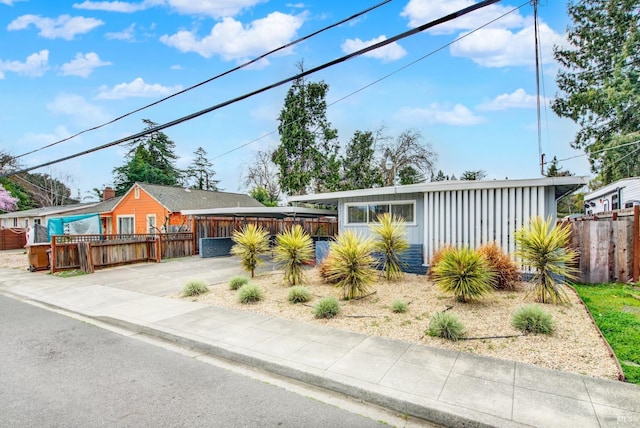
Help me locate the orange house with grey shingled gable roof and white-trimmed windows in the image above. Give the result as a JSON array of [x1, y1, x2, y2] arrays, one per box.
[[68, 183, 264, 234]]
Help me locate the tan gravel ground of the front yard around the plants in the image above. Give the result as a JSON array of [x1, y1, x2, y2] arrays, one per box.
[[179, 269, 618, 379]]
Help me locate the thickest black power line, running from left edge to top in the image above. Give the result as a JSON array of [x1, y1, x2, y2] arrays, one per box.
[[0, 0, 500, 178]]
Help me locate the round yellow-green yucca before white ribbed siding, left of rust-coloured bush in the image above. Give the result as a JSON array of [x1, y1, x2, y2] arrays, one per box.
[[432, 247, 496, 302]]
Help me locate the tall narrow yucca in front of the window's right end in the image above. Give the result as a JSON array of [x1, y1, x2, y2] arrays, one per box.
[[369, 213, 409, 281]]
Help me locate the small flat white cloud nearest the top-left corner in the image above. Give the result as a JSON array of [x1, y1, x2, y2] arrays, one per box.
[[7, 15, 104, 40]]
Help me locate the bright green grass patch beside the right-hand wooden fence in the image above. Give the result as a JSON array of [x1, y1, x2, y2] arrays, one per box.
[[574, 284, 640, 385]]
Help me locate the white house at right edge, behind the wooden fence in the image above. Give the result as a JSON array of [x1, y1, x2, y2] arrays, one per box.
[[584, 177, 640, 215]]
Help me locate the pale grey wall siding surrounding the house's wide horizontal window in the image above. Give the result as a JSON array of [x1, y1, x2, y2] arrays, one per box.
[[338, 193, 424, 245]]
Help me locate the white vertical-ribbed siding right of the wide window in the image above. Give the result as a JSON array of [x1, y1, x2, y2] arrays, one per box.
[[422, 186, 556, 263]]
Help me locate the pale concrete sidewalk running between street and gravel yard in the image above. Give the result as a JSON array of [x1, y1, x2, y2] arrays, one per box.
[[0, 265, 640, 427]]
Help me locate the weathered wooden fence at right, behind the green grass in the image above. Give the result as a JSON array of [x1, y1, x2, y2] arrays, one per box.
[[561, 206, 640, 284]]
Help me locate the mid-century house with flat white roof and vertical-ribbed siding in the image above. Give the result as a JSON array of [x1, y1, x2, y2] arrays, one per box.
[[288, 176, 588, 271]]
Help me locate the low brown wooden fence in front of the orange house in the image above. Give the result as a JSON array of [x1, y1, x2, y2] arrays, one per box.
[[51, 232, 194, 273]]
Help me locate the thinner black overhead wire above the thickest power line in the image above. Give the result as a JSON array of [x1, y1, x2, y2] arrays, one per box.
[[14, 0, 391, 159]]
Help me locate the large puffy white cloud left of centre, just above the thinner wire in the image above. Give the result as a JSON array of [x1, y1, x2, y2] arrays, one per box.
[[160, 12, 303, 61]]
